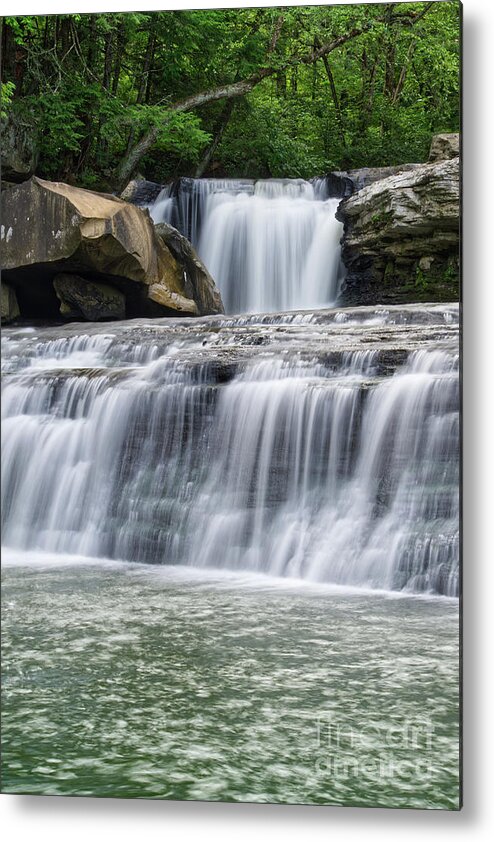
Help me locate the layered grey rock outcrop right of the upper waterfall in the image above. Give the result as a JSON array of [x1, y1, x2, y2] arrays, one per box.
[[337, 158, 459, 304]]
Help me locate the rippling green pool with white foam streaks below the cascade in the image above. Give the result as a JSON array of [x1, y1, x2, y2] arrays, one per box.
[[2, 563, 459, 809]]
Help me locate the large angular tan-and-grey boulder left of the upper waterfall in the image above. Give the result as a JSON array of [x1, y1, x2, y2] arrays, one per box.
[[1, 177, 222, 317]]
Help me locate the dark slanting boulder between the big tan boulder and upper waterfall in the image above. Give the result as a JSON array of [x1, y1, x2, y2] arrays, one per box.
[[155, 222, 224, 313]]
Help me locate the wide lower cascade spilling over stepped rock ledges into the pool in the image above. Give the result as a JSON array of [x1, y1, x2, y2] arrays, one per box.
[[2, 306, 459, 596]]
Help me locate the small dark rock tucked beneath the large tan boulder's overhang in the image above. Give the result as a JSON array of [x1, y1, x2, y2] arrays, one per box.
[[53, 274, 125, 322]]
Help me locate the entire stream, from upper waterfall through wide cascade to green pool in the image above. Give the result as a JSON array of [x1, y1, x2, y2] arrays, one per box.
[[1, 174, 459, 809]]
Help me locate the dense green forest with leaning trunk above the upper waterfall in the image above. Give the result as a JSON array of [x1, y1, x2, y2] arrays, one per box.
[[1, 0, 460, 187]]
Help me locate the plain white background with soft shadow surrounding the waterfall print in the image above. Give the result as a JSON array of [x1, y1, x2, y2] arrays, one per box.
[[0, 0, 494, 842]]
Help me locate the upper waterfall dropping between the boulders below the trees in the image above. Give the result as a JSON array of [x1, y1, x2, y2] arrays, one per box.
[[150, 179, 342, 313]]
